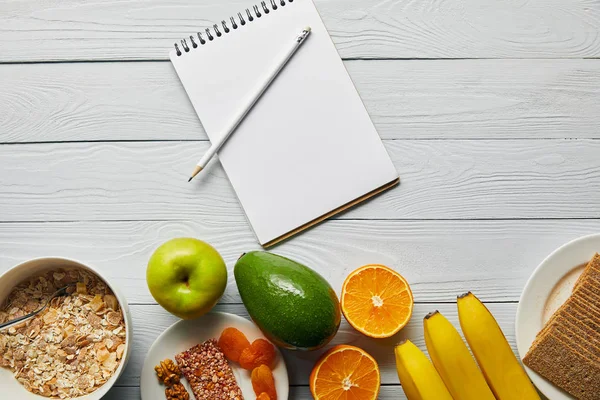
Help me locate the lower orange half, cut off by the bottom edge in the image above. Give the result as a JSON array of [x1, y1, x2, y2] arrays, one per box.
[[310, 345, 381, 400]]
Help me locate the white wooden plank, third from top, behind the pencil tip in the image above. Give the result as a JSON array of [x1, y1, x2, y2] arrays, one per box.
[[0, 140, 600, 221]]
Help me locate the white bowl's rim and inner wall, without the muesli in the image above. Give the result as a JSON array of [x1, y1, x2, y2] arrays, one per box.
[[0, 257, 132, 400]]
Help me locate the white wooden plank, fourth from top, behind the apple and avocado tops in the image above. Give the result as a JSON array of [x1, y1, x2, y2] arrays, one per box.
[[0, 219, 600, 304]]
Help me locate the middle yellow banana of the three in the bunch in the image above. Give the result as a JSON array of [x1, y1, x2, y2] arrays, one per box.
[[423, 311, 495, 400]]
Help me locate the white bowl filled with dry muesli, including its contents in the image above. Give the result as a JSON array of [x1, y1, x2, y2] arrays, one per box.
[[0, 258, 131, 400]]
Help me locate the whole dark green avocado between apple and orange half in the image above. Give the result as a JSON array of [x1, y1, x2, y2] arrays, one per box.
[[234, 251, 341, 350]]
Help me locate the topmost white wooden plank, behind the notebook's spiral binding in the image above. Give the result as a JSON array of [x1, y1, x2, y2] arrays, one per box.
[[0, 0, 600, 62]]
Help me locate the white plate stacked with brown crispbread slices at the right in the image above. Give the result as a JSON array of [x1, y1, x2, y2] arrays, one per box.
[[515, 234, 600, 400]]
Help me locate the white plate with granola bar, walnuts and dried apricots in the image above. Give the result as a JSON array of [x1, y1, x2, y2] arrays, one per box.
[[140, 312, 289, 400]]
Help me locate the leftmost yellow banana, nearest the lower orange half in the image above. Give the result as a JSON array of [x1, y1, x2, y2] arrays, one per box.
[[394, 340, 453, 400]]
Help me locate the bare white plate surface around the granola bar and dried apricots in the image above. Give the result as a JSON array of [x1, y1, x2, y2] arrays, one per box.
[[140, 312, 289, 400]]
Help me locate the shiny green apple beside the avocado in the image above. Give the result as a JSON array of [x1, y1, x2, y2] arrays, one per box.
[[146, 238, 227, 319]]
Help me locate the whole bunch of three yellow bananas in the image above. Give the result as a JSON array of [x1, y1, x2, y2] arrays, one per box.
[[395, 292, 540, 400]]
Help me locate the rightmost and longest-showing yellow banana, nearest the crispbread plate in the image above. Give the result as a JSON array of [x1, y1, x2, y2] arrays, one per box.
[[456, 292, 540, 400]]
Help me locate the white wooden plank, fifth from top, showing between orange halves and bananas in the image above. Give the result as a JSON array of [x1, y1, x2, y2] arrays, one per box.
[[113, 303, 517, 386]]
